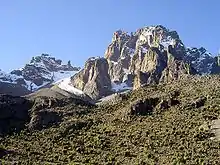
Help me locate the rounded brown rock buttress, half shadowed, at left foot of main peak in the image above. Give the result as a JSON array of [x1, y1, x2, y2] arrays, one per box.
[[72, 58, 111, 99]]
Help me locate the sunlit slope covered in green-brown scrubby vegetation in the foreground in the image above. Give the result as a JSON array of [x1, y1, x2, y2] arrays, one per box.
[[0, 76, 220, 165]]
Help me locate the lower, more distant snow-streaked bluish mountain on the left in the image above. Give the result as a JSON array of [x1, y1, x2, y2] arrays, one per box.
[[0, 54, 80, 95]]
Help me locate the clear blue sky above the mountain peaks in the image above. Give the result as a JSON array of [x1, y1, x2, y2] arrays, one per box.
[[0, 0, 220, 71]]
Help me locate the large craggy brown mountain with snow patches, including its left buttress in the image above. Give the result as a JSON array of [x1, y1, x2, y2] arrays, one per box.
[[71, 25, 220, 99]]
